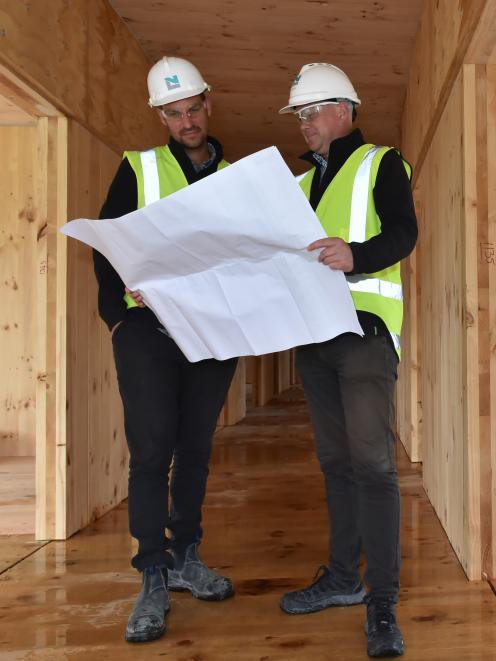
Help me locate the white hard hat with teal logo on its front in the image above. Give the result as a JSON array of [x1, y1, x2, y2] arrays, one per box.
[[147, 57, 210, 108]]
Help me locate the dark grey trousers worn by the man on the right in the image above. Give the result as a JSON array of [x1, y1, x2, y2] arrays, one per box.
[[297, 333, 400, 600]]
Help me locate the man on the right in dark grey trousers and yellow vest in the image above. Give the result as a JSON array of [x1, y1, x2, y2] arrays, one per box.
[[279, 63, 417, 657]]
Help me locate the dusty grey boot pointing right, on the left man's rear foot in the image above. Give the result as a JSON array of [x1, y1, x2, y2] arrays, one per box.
[[168, 544, 234, 601]]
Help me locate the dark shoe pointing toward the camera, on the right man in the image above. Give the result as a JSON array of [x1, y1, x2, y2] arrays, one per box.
[[365, 598, 404, 657]]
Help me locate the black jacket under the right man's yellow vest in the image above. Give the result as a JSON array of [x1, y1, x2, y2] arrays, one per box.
[[301, 129, 418, 337]]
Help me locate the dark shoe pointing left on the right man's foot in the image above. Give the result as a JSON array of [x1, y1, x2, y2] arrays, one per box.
[[279, 565, 365, 615]]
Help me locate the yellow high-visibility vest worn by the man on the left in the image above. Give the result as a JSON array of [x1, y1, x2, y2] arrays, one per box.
[[123, 145, 229, 308]]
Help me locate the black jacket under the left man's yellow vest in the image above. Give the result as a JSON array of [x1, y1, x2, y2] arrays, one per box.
[[93, 136, 223, 329]]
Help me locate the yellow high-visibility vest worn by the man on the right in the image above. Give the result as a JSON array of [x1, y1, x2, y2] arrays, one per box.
[[300, 144, 411, 355]]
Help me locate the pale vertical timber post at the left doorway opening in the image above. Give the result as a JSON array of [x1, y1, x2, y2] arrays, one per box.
[[33, 117, 67, 539]]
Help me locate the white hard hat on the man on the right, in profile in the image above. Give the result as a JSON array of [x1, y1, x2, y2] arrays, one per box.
[[279, 62, 360, 114]]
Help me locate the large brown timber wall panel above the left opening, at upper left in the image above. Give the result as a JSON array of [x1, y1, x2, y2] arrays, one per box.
[[0, 0, 163, 153]]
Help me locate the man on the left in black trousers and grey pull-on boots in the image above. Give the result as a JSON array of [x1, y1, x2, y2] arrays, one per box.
[[94, 57, 240, 642]]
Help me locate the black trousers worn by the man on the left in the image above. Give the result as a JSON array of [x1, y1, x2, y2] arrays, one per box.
[[112, 314, 237, 571]]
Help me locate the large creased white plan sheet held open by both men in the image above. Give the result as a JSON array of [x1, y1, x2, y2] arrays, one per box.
[[62, 147, 363, 361]]
